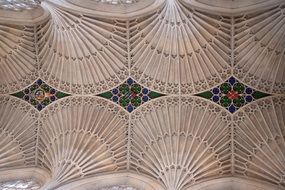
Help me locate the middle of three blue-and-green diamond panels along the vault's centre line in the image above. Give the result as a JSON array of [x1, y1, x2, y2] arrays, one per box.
[[98, 78, 164, 112]]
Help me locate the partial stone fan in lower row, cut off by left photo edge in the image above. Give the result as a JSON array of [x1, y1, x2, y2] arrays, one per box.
[[0, 96, 38, 169]]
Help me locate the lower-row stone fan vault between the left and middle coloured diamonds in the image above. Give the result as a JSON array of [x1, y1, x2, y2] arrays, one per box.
[[39, 97, 128, 187]]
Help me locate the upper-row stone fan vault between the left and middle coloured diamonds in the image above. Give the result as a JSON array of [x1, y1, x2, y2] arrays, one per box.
[[37, 3, 128, 94]]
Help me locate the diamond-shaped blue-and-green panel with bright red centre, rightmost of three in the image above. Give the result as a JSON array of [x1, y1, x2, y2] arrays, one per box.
[[196, 77, 269, 113]]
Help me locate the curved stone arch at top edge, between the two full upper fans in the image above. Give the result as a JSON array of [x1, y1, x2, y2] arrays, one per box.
[[47, 0, 165, 20]]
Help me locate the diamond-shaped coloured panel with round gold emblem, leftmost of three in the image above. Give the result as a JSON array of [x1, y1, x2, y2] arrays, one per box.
[[11, 79, 69, 111]]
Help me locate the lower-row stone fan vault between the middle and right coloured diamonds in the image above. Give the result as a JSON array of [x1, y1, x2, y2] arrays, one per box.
[[130, 97, 231, 190]]
